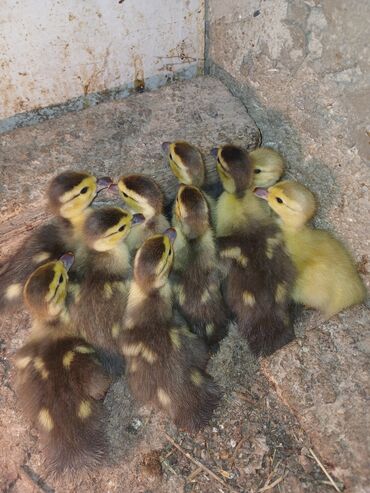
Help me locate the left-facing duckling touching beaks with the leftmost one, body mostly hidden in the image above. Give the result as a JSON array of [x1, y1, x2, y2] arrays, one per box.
[[111, 175, 170, 253]]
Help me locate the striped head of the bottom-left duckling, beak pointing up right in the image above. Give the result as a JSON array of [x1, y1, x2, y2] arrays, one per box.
[[24, 253, 74, 320]]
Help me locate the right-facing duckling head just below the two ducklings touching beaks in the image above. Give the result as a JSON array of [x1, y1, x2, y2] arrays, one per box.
[[83, 207, 144, 252]]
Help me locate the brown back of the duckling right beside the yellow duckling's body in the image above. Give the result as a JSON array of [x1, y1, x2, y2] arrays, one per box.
[[218, 223, 295, 355]]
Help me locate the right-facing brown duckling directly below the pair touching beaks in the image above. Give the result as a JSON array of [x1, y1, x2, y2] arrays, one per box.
[[70, 207, 144, 376]]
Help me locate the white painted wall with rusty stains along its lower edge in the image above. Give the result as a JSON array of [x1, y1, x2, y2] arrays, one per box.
[[0, 0, 204, 119]]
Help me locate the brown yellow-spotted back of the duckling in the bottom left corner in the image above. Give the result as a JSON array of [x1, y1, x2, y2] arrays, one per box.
[[15, 337, 110, 473]]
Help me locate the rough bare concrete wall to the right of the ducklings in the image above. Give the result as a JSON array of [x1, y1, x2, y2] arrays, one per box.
[[206, 0, 370, 290]]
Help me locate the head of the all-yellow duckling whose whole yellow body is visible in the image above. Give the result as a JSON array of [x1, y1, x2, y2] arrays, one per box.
[[255, 181, 316, 228]]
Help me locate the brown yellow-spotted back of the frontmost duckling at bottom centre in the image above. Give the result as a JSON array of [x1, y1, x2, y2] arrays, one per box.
[[120, 297, 219, 432]]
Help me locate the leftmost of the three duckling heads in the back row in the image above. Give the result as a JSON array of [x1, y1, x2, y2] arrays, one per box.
[[162, 141, 205, 187]]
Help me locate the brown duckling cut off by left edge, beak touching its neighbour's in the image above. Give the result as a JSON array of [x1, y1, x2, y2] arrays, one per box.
[[0, 171, 112, 311]]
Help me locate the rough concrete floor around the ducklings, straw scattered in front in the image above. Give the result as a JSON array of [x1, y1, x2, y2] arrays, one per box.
[[0, 77, 370, 493]]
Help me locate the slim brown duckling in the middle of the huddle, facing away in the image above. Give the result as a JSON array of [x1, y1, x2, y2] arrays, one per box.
[[173, 185, 228, 345]]
